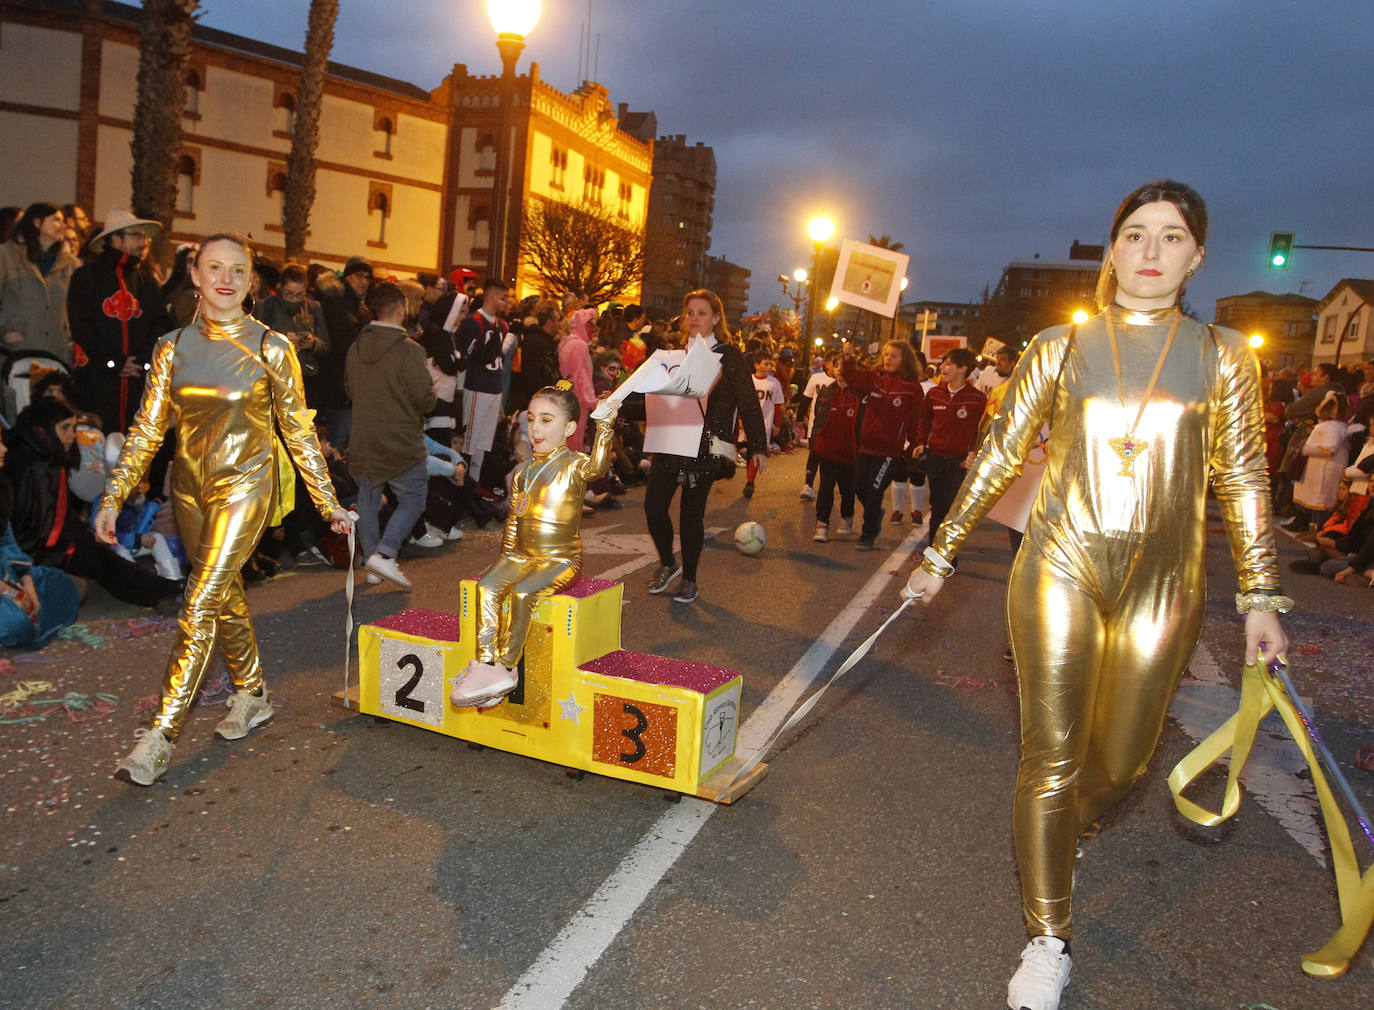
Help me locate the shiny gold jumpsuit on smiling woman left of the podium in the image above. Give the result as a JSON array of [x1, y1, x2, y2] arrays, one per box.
[[100, 317, 338, 741]]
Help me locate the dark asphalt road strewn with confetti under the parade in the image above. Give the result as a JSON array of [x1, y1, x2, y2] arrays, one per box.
[[0, 453, 1374, 1010]]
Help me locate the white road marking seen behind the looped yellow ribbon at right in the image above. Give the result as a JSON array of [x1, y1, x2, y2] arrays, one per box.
[[1169, 643, 1326, 866]]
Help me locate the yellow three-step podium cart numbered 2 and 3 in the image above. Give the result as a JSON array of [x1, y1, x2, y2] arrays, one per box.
[[334, 579, 767, 803]]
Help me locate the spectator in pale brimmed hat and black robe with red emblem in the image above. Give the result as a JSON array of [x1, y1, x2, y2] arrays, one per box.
[[67, 207, 172, 433]]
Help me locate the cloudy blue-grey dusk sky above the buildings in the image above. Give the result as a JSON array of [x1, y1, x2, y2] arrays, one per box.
[[202, 0, 1374, 317]]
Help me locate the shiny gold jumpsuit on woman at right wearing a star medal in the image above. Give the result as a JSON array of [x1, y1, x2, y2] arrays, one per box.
[[933, 306, 1279, 939]]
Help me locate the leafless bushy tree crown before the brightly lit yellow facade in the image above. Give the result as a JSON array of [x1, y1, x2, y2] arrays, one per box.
[[519, 201, 644, 304]]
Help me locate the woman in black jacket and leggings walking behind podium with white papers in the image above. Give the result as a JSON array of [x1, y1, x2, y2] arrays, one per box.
[[644, 289, 768, 603]]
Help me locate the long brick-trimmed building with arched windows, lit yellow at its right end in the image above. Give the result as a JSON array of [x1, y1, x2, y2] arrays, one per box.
[[0, 0, 653, 294]]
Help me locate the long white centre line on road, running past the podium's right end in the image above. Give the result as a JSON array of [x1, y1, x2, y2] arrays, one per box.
[[497, 529, 923, 1010]]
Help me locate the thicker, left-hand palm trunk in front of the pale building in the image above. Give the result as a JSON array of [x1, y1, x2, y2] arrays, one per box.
[[129, 0, 201, 262]]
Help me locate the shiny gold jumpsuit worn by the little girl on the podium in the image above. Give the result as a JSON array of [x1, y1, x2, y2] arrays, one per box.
[[477, 418, 616, 669]]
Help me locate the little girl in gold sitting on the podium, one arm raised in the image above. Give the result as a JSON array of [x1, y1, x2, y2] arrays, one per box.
[[449, 379, 616, 708]]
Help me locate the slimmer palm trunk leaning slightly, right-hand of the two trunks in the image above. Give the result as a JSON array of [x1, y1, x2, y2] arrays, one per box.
[[282, 0, 339, 261]]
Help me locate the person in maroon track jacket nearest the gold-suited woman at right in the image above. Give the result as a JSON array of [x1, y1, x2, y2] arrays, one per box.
[[915, 348, 988, 552]]
